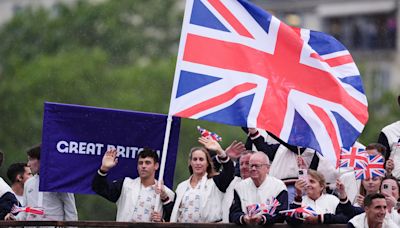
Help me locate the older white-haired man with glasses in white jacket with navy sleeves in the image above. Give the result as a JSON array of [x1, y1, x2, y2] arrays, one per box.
[[229, 152, 288, 225]]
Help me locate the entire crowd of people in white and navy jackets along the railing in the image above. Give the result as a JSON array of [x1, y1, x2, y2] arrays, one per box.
[[0, 96, 400, 227]]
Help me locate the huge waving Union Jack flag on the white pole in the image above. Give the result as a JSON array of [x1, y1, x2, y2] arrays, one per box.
[[169, 0, 368, 164]]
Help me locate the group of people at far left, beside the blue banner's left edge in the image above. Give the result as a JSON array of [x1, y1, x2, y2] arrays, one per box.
[[0, 145, 78, 221]]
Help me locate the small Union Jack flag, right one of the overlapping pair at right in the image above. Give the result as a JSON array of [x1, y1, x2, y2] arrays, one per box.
[[355, 154, 386, 180]]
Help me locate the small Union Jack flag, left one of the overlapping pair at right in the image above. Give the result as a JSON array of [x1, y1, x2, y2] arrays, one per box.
[[338, 147, 368, 169]]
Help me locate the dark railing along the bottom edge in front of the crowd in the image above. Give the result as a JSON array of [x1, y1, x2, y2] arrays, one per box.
[[0, 221, 347, 228]]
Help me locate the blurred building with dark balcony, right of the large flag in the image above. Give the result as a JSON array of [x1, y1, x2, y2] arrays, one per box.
[[253, 0, 400, 99]]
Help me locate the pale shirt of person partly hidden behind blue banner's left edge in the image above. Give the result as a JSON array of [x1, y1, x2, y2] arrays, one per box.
[[19, 175, 78, 221]]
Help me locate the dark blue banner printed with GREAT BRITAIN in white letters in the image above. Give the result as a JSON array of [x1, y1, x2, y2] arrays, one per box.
[[39, 102, 180, 194]]
